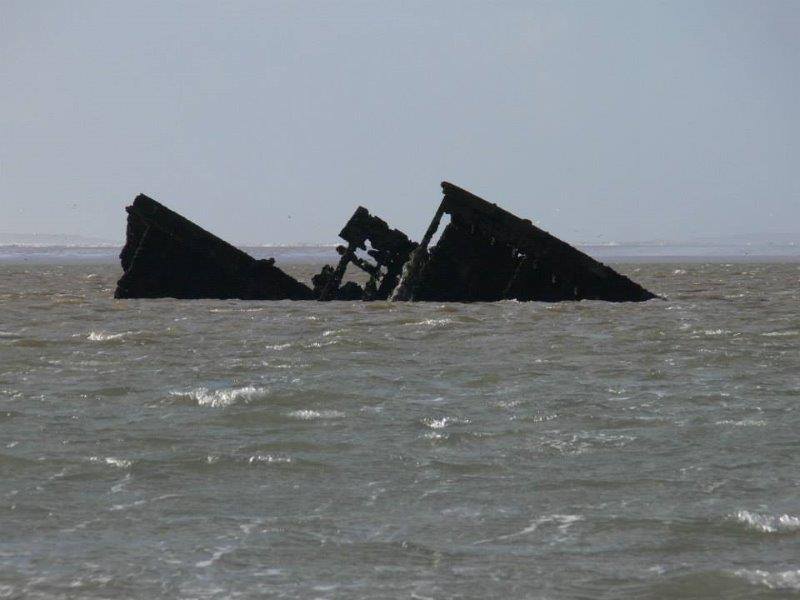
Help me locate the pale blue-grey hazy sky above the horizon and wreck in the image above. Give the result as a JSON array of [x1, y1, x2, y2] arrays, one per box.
[[0, 0, 800, 244]]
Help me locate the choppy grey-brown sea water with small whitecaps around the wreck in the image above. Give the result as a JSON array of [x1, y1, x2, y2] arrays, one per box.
[[0, 255, 800, 598]]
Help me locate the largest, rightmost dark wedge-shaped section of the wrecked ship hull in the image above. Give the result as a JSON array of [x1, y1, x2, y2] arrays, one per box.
[[393, 182, 656, 302]]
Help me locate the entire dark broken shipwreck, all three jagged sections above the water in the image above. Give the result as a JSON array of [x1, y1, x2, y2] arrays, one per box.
[[114, 182, 656, 302]]
